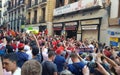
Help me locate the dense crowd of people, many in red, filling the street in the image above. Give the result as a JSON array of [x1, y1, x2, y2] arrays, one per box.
[[0, 28, 120, 75]]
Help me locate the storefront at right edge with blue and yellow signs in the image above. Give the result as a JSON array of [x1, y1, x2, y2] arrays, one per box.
[[108, 18, 120, 48]]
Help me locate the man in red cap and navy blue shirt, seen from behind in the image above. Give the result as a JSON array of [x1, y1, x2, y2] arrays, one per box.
[[17, 43, 28, 68]]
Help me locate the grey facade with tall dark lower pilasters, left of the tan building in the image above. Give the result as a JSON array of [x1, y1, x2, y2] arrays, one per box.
[[7, 0, 25, 31]]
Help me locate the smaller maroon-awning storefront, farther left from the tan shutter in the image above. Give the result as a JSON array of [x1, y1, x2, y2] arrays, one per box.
[[53, 23, 63, 35]]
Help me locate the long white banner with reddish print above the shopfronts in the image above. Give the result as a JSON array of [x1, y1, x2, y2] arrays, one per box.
[[53, 0, 102, 16]]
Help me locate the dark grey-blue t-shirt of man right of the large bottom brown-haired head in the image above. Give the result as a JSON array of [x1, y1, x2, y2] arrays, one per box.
[[42, 61, 57, 75]]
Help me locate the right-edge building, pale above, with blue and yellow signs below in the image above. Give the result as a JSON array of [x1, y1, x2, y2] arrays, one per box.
[[107, 0, 120, 48]]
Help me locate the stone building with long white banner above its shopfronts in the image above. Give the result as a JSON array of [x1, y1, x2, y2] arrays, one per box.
[[53, 0, 111, 45]]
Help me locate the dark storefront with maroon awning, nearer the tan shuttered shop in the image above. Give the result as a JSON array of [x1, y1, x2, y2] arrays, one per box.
[[64, 21, 79, 39]]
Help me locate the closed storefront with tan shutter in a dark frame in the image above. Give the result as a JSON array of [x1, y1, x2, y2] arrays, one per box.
[[80, 18, 101, 41]]
